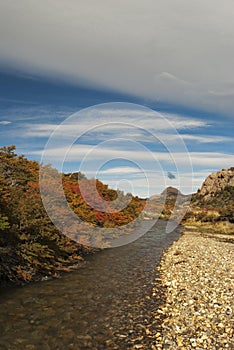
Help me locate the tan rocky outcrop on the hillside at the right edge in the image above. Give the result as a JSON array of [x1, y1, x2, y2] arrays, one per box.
[[199, 167, 234, 200]]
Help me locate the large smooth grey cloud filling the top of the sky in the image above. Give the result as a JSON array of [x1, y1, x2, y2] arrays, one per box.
[[0, 0, 234, 115]]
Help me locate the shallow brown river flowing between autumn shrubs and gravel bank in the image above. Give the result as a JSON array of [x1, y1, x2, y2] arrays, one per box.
[[0, 220, 179, 350]]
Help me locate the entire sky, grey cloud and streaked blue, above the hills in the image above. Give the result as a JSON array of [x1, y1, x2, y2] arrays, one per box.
[[0, 0, 234, 197]]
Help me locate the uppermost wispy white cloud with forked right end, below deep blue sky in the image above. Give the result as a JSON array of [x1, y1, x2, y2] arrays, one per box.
[[20, 110, 233, 145]]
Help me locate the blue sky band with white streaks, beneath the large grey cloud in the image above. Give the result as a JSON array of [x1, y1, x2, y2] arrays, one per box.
[[0, 70, 233, 196]]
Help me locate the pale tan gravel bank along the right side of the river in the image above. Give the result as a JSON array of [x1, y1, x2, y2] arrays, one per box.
[[154, 229, 234, 350]]
